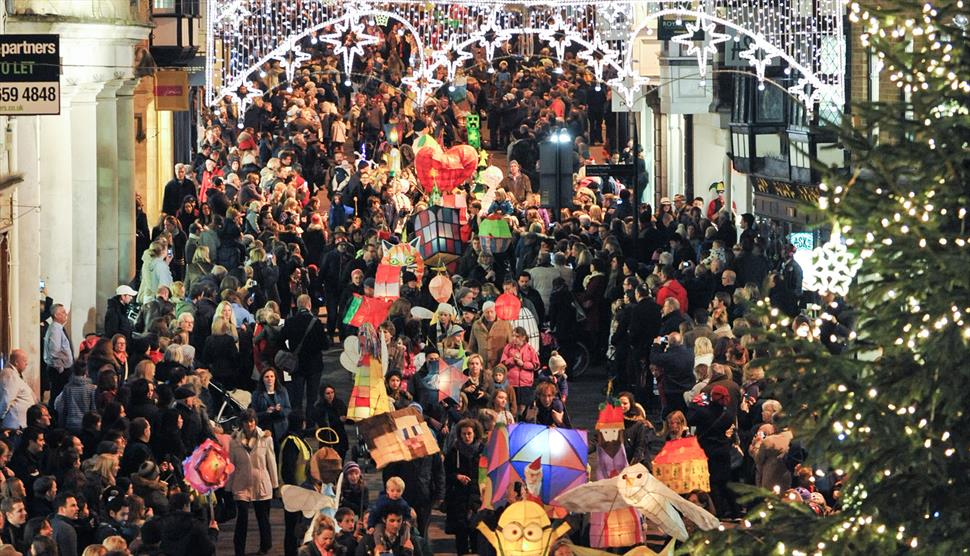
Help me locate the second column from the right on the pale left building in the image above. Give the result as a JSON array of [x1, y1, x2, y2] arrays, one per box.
[[94, 80, 122, 331]]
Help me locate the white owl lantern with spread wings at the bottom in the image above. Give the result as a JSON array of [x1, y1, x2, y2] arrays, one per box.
[[555, 463, 720, 541]]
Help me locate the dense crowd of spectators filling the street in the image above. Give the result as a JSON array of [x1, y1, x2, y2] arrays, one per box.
[[0, 23, 851, 556]]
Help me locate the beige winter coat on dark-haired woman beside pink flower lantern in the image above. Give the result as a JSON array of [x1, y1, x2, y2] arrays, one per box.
[[226, 427, 279, 502]]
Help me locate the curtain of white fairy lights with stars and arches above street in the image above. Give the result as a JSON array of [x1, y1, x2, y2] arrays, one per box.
[[206, 0, 845, 111]]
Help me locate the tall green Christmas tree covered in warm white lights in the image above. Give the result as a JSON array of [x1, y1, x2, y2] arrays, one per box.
[[690, 1, 970, 555]]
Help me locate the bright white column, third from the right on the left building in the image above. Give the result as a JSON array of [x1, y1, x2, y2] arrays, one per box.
[[69, 82, 105, 340]]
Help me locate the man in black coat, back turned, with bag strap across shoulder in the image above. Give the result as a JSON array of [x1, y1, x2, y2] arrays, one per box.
[[283, 294, 330, 409]]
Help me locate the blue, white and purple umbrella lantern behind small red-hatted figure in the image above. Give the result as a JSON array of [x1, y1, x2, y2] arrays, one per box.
[[509, 423, 589, 504]]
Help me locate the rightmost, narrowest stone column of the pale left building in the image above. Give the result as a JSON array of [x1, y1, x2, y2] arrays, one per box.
[[117, 80, 138, 284]]
